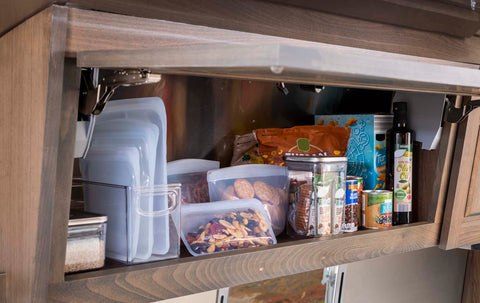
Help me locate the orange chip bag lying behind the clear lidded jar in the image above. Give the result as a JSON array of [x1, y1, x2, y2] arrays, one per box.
[[255, 125, 350, 165]]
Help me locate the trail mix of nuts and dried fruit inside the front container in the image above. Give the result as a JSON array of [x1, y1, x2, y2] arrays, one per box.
[[186, 209, 273, 254]]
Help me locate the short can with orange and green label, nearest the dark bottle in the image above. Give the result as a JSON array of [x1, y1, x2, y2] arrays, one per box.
[[362, 190, 393, 229]]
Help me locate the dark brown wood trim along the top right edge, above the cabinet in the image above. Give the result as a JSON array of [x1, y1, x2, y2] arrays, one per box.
[[262, 0, 480, 38]]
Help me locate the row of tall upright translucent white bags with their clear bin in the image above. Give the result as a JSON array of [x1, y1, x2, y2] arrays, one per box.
[[80, 98, 180, 263]]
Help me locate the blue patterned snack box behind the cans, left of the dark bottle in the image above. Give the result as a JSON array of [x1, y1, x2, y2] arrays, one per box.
[[315, 114, 393, 190]]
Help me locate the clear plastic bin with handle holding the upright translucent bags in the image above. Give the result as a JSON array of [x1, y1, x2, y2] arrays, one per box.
[[83, 181, 181, 264]]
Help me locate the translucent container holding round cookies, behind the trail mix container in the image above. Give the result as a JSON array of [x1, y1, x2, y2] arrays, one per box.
[[207, 164, 289, 235]]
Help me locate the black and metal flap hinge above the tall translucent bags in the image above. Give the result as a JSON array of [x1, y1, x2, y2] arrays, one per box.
[[79, 69, 161, 116]]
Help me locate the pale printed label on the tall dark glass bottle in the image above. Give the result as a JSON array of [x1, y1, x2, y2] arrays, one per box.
[[393, 144, 413, 212]]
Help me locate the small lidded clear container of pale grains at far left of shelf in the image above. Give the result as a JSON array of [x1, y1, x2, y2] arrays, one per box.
[[65, 211, 107, 273]]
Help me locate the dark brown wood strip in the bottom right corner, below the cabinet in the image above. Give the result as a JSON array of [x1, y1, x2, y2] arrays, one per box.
[[462, 250, 480, 303]]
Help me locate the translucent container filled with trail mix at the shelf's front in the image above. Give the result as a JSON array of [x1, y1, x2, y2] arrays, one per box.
[[182, 199, 277, 256]]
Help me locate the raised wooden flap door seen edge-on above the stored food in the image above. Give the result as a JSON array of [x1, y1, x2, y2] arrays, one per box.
[[77, 43, 480, 94]]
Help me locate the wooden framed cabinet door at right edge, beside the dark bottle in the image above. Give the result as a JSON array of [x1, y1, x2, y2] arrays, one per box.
[[440, 108, 480, 249]]
